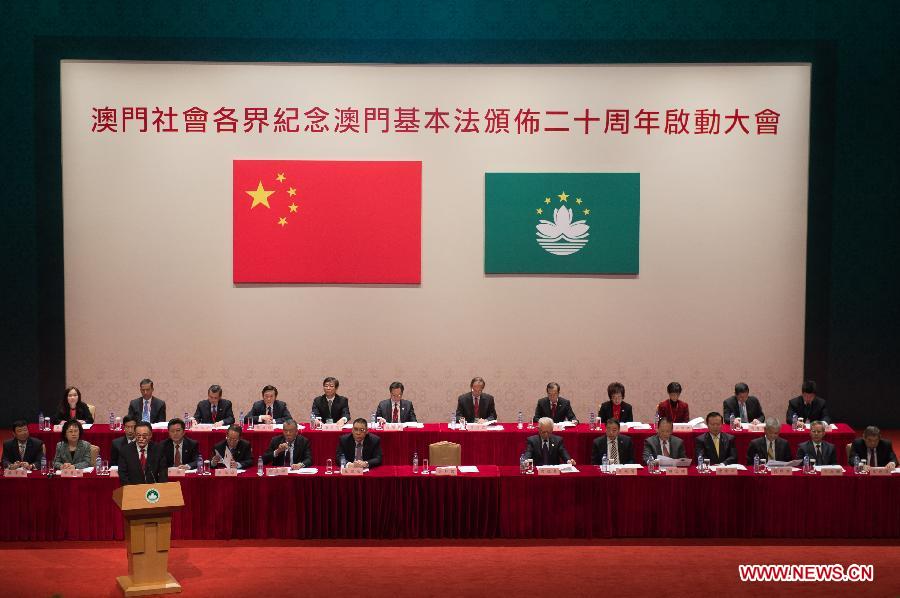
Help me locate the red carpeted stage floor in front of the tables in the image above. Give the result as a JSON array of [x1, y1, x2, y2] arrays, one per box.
[[0, 540, 900, 598]]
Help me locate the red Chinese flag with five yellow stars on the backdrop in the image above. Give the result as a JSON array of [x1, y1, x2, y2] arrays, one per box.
[[234, 160, 422, 284]]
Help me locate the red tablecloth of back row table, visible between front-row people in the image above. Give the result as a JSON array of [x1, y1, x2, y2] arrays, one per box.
[[29, 423, 855, 466]]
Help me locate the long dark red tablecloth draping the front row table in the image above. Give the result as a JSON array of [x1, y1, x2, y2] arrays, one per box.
[[0, 465, 900, 541]]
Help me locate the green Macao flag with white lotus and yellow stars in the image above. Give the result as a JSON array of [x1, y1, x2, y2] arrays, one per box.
[[484, 173, 640, 274]]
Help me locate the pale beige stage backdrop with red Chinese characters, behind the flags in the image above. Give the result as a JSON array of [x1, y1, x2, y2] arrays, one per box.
[[60, 61, 810, 421]]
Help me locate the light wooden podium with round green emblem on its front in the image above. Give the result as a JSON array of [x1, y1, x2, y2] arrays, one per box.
[[113, 482, 184, 596]]
